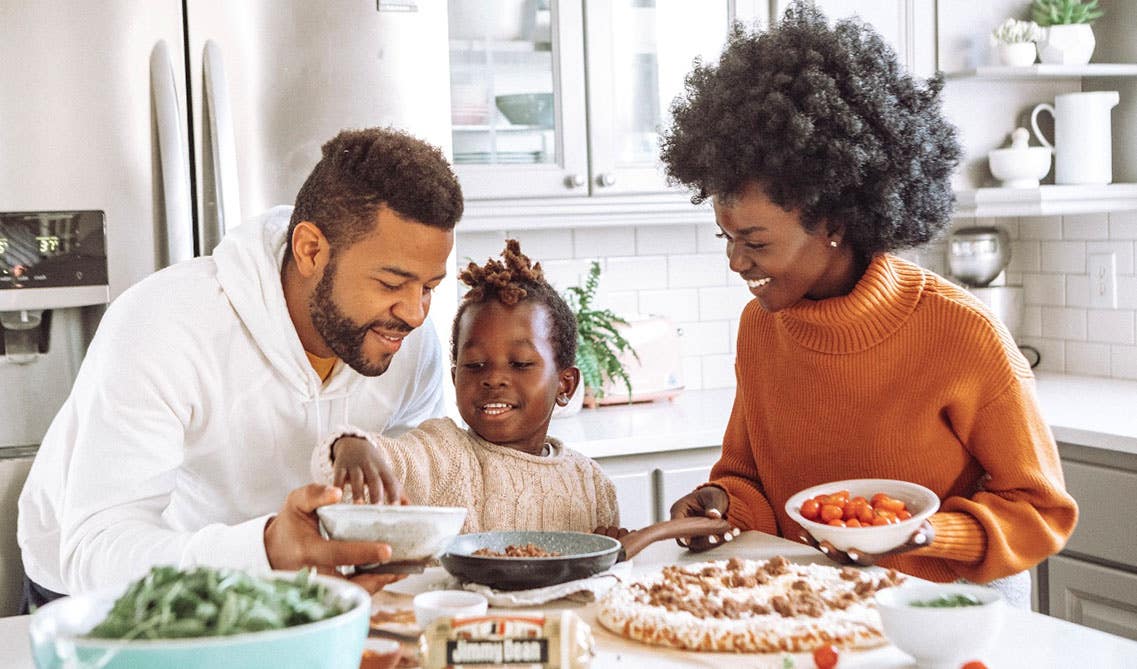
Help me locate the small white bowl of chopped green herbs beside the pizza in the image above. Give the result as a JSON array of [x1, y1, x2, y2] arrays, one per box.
[[873, 580, 1005, 669]]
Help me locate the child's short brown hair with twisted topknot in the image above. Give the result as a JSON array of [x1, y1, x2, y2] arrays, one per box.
[[450, 239, 576, 370]]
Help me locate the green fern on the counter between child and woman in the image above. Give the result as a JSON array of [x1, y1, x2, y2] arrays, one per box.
[[565, 261, 639, 406]]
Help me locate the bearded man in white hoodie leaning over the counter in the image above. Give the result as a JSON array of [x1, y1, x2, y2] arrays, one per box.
[[18, 129, 463, 605]]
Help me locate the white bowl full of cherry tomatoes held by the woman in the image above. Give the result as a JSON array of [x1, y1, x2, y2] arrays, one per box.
[[786, 479, 939, 554]]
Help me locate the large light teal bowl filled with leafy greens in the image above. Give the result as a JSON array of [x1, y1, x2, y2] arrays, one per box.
[[28, 567, 371, 669]]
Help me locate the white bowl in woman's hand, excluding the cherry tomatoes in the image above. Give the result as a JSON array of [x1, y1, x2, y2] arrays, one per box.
[[786, 479, 939, 554]]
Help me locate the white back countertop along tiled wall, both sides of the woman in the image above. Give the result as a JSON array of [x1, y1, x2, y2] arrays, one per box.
[[549, 373, 1137, 457]]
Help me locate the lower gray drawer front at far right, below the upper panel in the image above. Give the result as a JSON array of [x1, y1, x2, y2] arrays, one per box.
[[1048, 552, 1137, 641]]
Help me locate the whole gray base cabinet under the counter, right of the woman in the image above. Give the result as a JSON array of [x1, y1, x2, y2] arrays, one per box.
[[1039, 444, 1137, 639]]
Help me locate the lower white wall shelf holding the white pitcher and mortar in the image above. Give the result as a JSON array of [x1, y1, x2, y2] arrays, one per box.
[[955, 183, 1137, 216]]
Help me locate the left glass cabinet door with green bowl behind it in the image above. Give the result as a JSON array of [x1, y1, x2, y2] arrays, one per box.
[[448, 0, 588, 198]]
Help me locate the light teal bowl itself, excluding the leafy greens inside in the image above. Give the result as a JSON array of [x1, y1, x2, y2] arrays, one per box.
[[28, 571, 371, 669]]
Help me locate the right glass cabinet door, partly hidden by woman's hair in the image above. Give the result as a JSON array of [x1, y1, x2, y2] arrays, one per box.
[[584, 0, 731, 195]]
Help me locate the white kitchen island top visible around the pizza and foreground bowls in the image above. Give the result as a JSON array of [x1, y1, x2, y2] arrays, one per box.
[[0, 532, 1137, 669]]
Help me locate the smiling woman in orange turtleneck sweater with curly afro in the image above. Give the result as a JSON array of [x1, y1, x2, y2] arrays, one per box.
[[663, 3, 1077, 605]]
